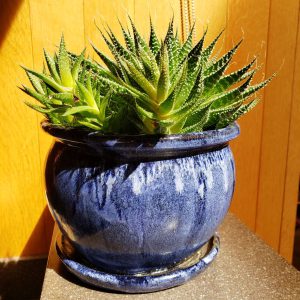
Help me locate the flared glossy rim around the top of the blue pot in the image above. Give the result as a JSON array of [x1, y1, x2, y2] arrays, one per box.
[[41, 120, 240, 159]]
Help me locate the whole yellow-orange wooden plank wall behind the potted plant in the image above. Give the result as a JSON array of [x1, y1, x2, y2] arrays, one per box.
[[0, 0, 300, 260]]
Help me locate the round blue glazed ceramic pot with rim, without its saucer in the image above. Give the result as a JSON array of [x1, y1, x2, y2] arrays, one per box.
[[42, 122, 239, 274]]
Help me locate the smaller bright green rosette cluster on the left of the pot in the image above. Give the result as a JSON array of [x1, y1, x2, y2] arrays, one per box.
[[21, 36, 112, 130]]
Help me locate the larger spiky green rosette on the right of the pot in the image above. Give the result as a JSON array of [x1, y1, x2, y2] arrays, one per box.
[[93, 19, 271, 134]]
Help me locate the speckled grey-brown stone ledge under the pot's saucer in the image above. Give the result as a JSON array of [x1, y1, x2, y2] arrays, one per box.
[[41, 214, 300, 300]]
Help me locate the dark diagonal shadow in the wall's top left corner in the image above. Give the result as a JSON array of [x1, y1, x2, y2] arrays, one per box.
[[0, 0, 23, 48]]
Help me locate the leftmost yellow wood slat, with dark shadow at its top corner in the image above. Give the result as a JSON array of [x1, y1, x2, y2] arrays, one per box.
[[0, 0, 47, 257]]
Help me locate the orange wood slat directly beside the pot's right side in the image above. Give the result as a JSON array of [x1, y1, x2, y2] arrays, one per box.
[[227, 0, 272, 230]]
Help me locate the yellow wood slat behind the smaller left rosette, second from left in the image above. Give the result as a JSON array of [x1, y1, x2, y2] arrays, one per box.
[[29, 0, 84, 251]]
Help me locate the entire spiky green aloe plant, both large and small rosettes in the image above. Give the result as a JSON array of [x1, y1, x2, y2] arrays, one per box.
[[23, 19, 273, 134]]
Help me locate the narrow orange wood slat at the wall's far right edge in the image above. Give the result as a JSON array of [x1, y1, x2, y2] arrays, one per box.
[[279, 7, 300, 262]]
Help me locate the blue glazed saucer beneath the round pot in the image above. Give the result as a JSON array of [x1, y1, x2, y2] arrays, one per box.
[[56, 234, 220, 293]]
